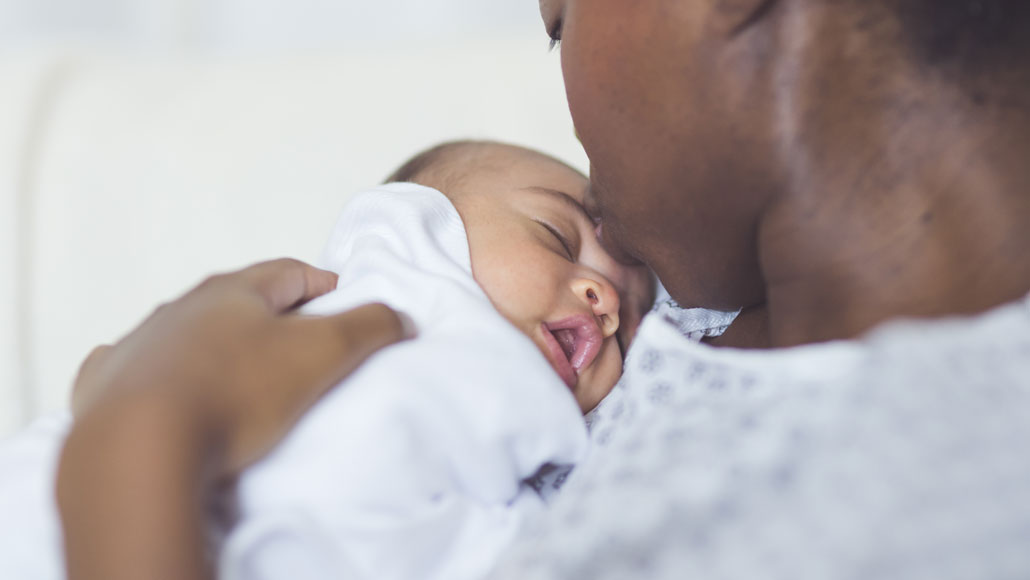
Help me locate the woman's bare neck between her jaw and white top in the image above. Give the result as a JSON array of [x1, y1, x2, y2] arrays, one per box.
[[759, 89, 1030, 346]]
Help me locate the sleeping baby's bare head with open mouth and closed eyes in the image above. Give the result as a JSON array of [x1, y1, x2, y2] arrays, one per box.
[[388, 141, 655, 412]]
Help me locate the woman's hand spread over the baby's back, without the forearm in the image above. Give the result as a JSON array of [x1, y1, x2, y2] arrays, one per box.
[[66, 260, 410, 475]]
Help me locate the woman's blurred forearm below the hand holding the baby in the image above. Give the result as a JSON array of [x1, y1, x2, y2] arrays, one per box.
[[58, 387, 216, 580]]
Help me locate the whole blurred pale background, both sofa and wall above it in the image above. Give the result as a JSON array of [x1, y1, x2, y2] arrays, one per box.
[[0, 0, 586, 437]]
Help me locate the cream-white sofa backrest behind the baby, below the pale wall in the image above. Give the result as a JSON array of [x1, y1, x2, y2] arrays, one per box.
[[0, 40, 586, 437]]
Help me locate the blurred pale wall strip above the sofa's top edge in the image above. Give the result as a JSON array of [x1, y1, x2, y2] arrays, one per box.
[[0, 0, 546, 56]]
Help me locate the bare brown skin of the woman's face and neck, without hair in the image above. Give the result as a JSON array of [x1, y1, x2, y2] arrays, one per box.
[[540, 0, 1030, 345]]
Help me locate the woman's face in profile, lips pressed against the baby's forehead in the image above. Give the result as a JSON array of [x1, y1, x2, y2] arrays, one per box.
[[540, 0, 773, 309]]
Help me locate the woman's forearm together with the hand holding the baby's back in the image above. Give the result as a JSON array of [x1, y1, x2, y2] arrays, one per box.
[[58, 261, 406, 580]]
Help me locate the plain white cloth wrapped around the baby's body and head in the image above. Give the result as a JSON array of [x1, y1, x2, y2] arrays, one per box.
[[220, 184, 587, 580]]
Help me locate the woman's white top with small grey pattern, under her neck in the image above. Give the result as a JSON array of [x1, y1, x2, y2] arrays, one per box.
[[491, 302, 1030, 580]]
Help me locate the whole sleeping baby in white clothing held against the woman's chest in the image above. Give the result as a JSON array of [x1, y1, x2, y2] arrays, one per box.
[[219, 142, 655, 580]]
